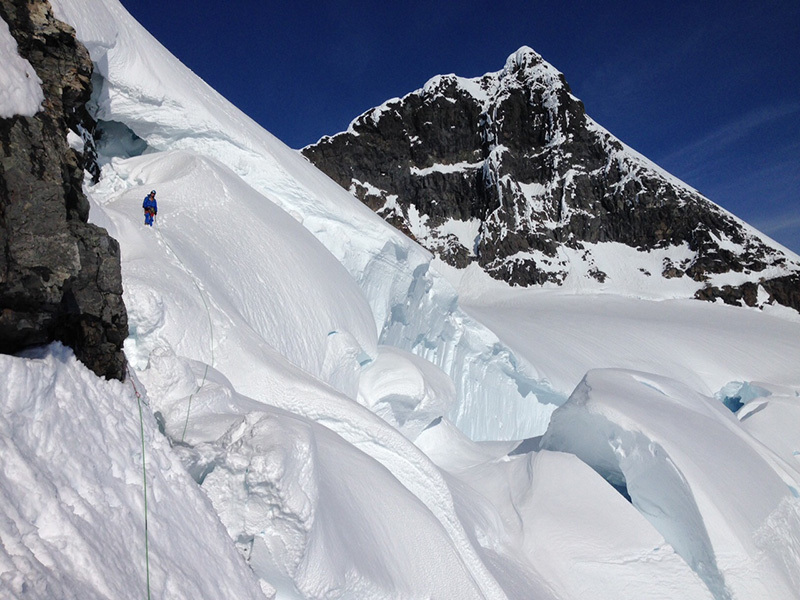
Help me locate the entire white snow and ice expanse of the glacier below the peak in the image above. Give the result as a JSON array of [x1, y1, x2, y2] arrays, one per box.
[[0, 0, 800, 600]]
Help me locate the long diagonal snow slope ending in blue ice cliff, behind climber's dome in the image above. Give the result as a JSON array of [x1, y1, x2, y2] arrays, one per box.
[[53, 0, 565, 439]]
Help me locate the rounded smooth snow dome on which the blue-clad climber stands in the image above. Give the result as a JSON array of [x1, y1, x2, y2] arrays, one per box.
[[90, 151, 377, 397]]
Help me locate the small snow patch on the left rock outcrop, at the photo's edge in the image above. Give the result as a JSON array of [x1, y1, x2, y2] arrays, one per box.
[[0, 18, 44, 119]]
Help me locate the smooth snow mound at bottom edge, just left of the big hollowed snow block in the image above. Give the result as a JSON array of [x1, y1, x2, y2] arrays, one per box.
[[417, 422, 712, 600]]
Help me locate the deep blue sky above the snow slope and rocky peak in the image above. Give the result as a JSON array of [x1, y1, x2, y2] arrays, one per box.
[[122, 0, 800, 252]]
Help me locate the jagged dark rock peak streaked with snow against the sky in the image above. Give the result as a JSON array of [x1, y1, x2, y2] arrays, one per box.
[[302, 48, 800, 310]]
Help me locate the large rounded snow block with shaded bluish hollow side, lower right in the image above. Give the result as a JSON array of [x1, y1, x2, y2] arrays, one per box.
[[541, 370, 800, 599]]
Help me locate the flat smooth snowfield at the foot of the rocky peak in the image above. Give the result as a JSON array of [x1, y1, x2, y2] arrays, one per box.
[[450, 262, 800, 395]]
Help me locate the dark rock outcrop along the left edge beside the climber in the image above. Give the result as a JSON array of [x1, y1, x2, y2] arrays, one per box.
[[0, 0, 128, 379]]
